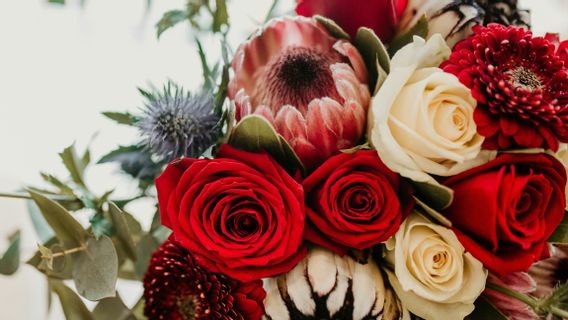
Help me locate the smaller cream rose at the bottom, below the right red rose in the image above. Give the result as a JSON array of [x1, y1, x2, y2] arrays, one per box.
[[386, 212, 487, 320]]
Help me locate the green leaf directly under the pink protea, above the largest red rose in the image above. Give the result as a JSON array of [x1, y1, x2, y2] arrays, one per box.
[[229, 115, 302, 172]]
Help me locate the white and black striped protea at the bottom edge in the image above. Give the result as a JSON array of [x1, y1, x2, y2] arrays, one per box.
[[264, 248, 411, 320]]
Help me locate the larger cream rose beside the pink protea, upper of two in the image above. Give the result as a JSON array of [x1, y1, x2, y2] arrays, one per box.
[[368, 34, 490, 183]]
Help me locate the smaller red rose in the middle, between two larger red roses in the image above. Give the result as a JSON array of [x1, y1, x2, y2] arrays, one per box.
[[303, 150, 414, 254]]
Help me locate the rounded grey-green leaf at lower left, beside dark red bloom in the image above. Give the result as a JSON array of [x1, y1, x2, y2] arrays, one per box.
[[73, 236, 118, 301]]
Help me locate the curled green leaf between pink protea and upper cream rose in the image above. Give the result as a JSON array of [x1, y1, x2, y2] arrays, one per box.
[[354, 27, 390, 89]]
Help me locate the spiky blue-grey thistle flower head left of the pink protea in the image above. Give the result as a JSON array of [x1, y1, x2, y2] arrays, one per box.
[[138, 82, 220, 161]]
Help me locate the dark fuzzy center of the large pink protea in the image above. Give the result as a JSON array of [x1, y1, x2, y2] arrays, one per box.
[[253, 47, 342, 114]]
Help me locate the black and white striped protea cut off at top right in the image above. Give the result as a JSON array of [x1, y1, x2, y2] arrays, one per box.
[[399, 0, 530, 47]]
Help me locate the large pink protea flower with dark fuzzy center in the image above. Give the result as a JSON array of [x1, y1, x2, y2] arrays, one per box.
[[229, 17, 370, 169]]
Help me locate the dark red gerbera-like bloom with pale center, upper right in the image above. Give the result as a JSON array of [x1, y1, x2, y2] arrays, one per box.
[[442, 24, 568, 150]]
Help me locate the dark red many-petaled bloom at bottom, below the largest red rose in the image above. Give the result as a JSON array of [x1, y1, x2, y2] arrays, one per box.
[[144, 238, 266, 320]]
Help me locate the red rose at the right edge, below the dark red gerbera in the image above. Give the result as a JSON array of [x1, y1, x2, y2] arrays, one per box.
[[443, 153, 566, 275]]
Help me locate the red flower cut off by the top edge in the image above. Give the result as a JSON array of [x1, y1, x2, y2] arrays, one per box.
[[296, 0, 408, 42]]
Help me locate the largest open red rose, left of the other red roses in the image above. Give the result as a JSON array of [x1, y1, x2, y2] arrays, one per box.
[[156, 145, 306, 281]]
